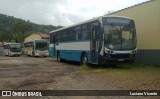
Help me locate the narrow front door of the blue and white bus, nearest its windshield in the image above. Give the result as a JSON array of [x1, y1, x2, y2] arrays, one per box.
[[90, 26, 98, 64]]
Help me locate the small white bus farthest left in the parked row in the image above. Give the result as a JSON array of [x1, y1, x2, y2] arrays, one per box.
[[3, 43, 22, 56]]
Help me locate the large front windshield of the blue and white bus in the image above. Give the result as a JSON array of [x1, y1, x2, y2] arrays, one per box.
[[104, 19, 136, 50]]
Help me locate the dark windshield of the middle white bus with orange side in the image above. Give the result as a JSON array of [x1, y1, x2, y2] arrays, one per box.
[[35, 42, 48, 51]]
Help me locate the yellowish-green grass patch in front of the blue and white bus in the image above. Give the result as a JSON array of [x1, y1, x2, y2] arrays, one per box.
[[80, 64, 160, 90]]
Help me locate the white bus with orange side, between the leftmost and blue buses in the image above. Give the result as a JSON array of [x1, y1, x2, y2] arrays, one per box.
[[23, 39, 49, 56]]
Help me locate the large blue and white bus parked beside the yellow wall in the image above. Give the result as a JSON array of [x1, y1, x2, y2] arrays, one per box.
[[50, 16, 137, 64]]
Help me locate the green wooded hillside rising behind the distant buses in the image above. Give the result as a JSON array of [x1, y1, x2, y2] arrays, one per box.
[[0, 14, 62, 42]]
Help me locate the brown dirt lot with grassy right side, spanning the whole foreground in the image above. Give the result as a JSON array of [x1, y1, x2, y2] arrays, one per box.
[[0, 56, 160, 99]]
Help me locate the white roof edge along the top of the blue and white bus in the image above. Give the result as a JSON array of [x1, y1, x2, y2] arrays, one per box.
[[50, 15, 133, 33]]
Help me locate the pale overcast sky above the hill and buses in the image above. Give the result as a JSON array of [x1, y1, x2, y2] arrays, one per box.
[[0, 0, 148, 26]]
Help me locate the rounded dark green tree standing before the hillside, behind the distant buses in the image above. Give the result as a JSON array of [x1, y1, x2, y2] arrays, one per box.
[[11, 20, 32, 43]]
